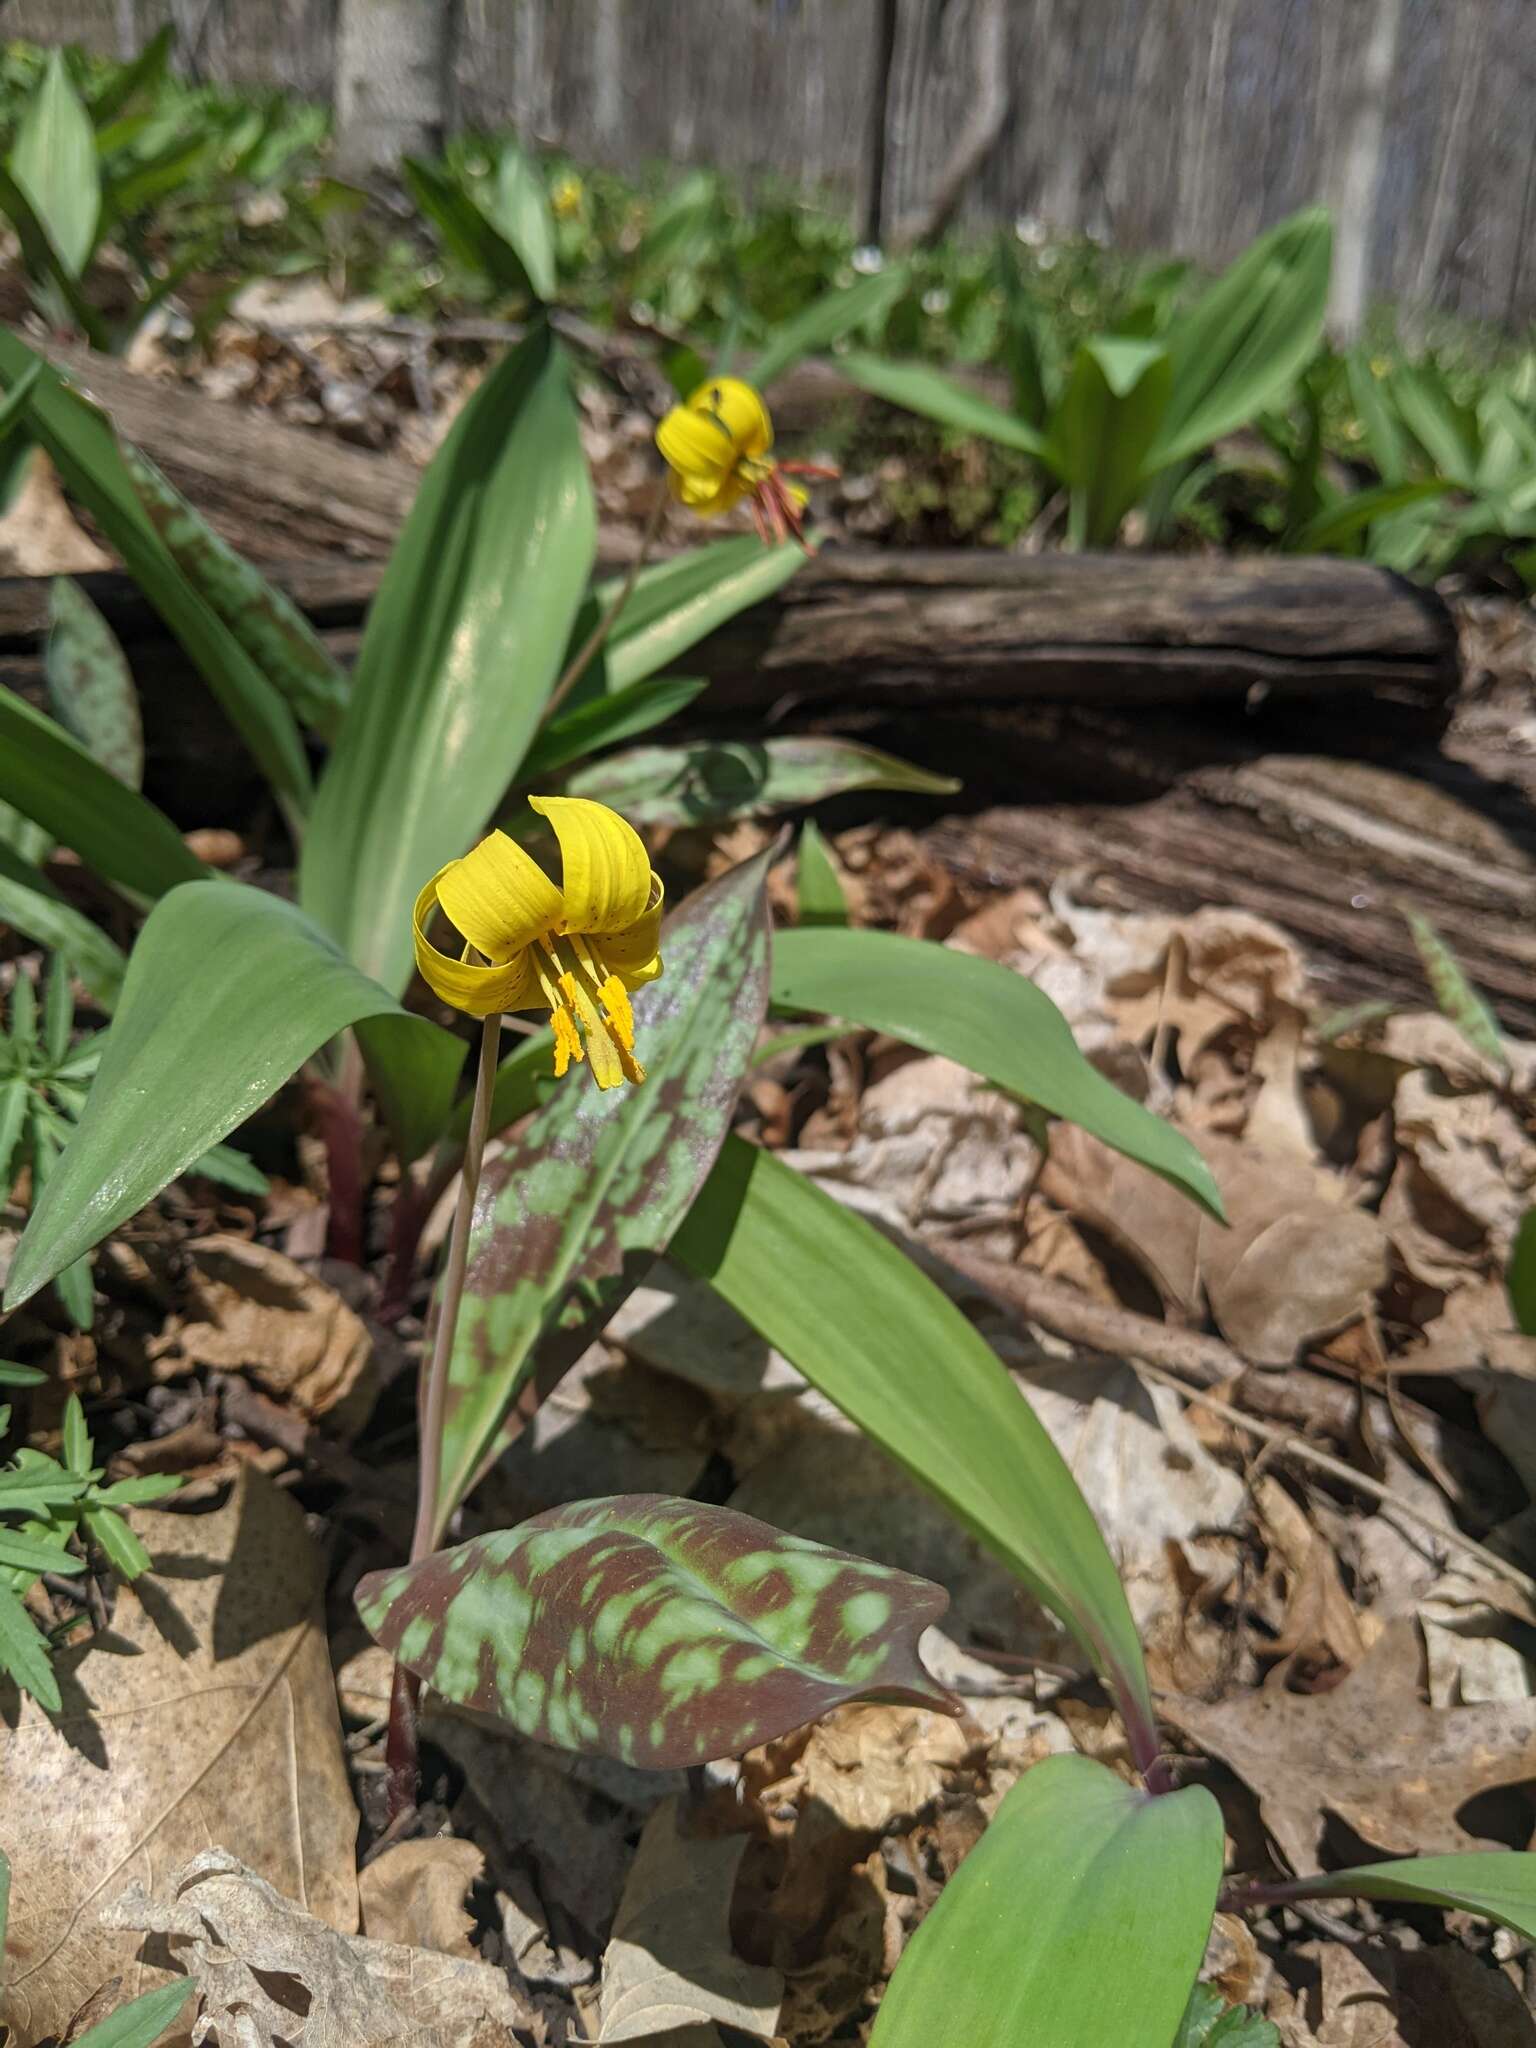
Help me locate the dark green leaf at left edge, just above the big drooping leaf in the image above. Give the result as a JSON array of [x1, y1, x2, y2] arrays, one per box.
[[0, 690, 207, 897]]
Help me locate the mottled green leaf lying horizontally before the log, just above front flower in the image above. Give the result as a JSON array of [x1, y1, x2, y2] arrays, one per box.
[[565, 739, 961, 825]]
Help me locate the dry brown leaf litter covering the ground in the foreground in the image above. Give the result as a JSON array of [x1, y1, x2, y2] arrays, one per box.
[[0, 634, 1536, 2048]]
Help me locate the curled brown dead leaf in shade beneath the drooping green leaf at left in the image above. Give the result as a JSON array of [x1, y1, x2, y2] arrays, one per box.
[[160, 1237, 377, 1432]]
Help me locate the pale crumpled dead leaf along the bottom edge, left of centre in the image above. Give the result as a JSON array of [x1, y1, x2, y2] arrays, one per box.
[[109, 1849, 522, 2048]]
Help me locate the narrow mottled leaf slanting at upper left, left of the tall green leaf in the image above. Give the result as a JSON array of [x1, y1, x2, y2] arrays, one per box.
[[123, 446, 346, 739]]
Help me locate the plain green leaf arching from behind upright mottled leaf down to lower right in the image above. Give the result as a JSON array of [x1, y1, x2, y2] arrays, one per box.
[[670, 1146, 1153, 1737]]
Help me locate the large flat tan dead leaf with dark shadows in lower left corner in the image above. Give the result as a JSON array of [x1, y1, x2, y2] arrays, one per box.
[[0, 1473, 358, 2040]]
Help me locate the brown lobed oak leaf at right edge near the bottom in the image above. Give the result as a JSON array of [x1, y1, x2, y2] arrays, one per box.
[[1159, 1620, 1536, 1876]]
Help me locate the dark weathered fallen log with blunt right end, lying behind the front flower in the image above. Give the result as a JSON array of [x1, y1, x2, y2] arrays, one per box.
[[0, 549, 1458, 735]]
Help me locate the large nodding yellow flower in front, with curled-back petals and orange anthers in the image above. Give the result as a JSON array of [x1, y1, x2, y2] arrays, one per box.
[[412, 797, 662, 1087]]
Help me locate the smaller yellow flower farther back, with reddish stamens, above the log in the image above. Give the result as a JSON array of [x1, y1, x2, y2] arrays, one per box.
[[655, 377, 838, 547]]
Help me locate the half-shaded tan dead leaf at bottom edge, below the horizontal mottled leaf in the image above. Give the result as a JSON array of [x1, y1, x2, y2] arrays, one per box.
[[598, 1800, 784, 2048]]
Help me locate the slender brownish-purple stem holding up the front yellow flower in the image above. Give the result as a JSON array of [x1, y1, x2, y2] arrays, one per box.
[[385, 1012, 502, 1823]]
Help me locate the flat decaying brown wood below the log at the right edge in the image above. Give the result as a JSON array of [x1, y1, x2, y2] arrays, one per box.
[[930, 715, 1536, 1038]]
